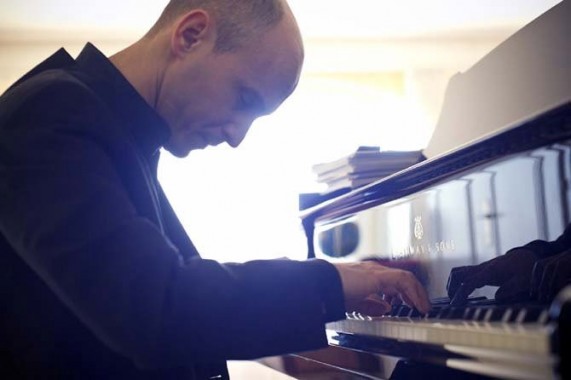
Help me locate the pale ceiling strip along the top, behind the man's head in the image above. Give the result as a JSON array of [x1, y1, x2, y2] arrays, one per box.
[[0, 0, 560, 39]]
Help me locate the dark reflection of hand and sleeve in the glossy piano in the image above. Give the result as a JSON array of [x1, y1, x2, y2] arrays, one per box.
[[447, 225, 571, 305]]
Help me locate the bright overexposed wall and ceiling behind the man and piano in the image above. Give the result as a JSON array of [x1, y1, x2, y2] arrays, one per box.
[[0, 0, 559, 261]]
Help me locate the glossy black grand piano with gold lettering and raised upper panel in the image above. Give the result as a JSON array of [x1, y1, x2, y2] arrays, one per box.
[[266, 0, 571, 380]]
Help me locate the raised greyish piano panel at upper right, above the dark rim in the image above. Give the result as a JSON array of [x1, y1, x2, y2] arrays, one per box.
[[423, 0, 571, 158]]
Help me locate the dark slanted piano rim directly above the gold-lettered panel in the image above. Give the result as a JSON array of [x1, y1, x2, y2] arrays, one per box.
[[300, 101, 571, 226]]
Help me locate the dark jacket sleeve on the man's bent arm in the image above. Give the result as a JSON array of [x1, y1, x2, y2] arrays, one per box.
[[0, 76, 344, 368]]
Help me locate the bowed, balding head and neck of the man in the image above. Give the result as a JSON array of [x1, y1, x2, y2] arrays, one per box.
[[111, 0, 304, 157]]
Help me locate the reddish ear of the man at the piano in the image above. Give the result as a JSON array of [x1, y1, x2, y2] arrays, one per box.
[[171, 9, 216, 56]]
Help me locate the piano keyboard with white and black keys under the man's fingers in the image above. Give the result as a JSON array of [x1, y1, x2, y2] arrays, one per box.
[[327, 300, 554, 354]]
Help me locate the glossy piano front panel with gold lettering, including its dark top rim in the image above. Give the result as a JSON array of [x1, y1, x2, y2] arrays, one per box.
[[304, 104, 571, 298]]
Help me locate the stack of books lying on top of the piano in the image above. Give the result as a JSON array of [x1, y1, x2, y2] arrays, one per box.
[[312, 147, 424, 193]]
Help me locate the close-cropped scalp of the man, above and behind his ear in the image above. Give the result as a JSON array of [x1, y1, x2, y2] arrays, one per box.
[[147, 0, 287, 52]]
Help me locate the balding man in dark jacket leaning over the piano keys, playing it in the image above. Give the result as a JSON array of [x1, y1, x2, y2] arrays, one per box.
[[0, 0, 429, 379]]
